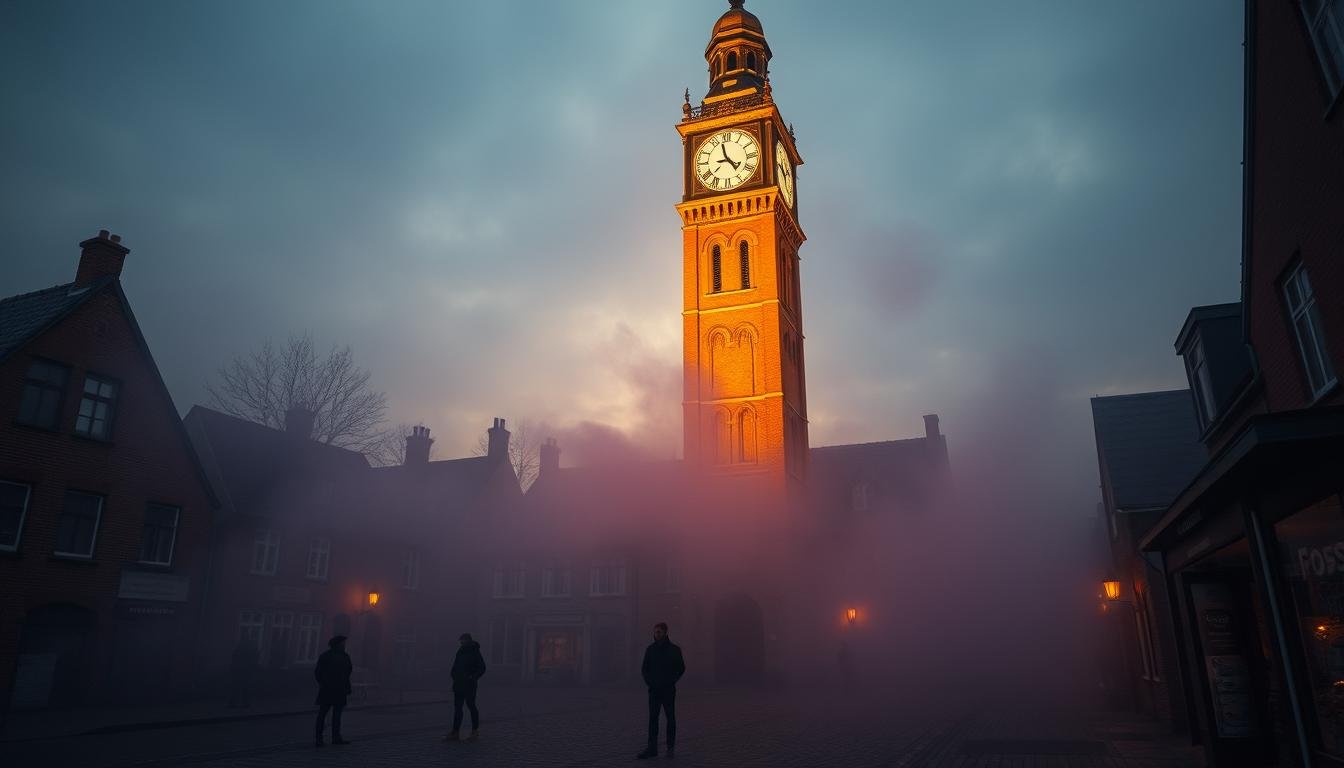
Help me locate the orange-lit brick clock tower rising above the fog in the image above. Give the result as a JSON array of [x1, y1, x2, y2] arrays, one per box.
[[676, 0, 808, 500]]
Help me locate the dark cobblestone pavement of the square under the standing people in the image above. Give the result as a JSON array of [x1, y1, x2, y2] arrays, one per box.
[[0, 690, 1199, 768]]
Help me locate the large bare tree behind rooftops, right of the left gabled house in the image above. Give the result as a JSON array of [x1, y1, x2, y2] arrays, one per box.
[[206, 334, 388, 452]]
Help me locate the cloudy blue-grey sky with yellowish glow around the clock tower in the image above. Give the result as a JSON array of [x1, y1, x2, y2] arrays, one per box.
[[0, 0, 1242, 515]]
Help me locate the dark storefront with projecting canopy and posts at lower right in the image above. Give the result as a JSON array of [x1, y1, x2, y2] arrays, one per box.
[[1141, 409, 1344, 767]]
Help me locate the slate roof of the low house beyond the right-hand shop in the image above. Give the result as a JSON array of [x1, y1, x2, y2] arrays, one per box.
[[1091, 389, 1208, 510]]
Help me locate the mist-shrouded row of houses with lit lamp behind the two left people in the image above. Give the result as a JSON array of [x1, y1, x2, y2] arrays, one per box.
[[185, 406, 520, 694]]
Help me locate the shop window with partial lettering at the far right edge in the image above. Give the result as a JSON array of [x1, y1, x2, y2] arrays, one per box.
[[1274, 496, 1344, 757]]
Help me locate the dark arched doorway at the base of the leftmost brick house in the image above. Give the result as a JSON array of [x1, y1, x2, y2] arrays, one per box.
[[11, 603, 98, 709]]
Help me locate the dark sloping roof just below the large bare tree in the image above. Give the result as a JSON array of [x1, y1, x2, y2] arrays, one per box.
[[184, 405, 368, 515]]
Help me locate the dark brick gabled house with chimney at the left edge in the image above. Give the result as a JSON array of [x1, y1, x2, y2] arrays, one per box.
[[0, 230, 214, 709]]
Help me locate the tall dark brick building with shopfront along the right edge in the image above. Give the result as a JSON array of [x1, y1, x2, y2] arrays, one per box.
[[1141, 0, 1344, 765]]
